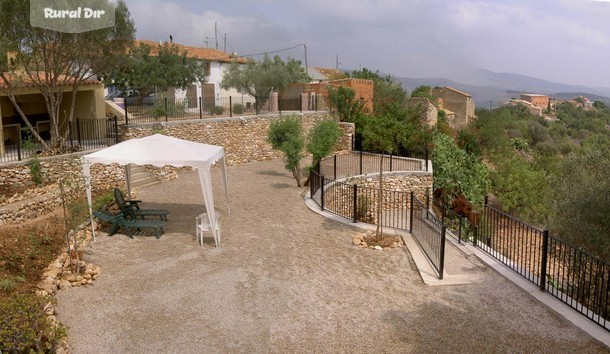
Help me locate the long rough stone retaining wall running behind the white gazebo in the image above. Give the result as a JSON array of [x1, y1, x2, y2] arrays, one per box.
[[0, 113, 355, 226]]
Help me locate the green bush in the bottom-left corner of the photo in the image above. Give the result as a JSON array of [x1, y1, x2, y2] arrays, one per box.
[[0, 294, 66, 353]]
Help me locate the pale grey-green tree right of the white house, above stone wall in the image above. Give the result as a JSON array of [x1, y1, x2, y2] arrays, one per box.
[[222, 55, 309, 110]]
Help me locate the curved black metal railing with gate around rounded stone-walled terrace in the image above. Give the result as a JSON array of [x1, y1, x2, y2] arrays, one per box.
[[309, 152, 446, 279]]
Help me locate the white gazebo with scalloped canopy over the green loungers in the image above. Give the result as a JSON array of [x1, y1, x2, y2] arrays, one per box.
[[81, 134, 229, 245]]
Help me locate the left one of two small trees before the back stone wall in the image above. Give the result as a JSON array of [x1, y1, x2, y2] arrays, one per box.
[[267, 116, 305, 187]]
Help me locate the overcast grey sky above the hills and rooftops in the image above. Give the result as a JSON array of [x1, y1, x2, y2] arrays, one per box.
[[125, 0, 610, 87]]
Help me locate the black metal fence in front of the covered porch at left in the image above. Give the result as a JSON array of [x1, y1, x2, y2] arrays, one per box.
[[0, 117, 119, 163]]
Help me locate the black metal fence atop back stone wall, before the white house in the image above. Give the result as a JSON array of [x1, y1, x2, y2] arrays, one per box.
[[119, 96, 318, 124]]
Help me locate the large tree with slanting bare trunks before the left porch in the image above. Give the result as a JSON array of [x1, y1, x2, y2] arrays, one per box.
[[0, 0, 135, 148]]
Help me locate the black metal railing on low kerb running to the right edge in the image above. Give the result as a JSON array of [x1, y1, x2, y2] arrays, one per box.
[[473, 198, 610, 331]]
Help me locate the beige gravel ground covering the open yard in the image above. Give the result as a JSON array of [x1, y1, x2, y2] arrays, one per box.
[[57, 161, 608, 353]]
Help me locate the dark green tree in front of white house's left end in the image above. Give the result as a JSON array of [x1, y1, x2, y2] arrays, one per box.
[[100, 42, 207, 101]]
